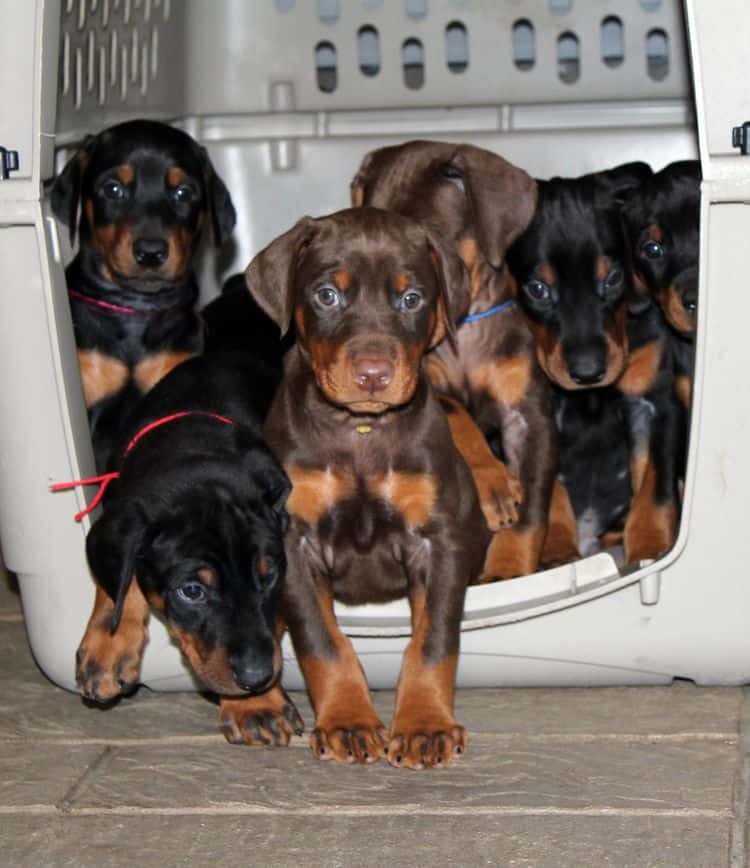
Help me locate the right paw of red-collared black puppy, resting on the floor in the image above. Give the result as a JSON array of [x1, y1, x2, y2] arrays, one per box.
[[220, 685, 305, 747]]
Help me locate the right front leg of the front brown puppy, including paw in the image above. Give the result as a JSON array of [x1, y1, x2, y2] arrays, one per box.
[[388, 552, 466, 769]]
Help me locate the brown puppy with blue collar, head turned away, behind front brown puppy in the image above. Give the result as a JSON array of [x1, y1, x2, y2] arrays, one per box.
[[352, 141, 574, 578]]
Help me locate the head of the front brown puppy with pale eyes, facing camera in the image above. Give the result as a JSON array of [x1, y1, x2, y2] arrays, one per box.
[[246, 208, 469, 413]]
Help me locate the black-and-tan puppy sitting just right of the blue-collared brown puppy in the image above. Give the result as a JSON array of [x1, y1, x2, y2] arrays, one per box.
[[508, 163, 678, 563]]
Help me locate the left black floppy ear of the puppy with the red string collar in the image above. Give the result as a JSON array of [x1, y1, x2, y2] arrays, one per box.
[[86, 498, 147, 633]]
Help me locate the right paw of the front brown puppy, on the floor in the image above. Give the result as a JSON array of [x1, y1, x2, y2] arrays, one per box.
[[388, 720, 466, 769]]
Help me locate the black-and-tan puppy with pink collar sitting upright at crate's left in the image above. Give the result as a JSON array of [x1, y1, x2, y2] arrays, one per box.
[[51, 120, 235, 469]]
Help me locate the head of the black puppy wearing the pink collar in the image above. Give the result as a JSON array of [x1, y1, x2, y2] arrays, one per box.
[[51, 120, 235, 292]]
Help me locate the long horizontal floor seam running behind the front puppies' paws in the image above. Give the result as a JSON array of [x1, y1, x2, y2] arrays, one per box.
[[0, 731, 739, 748]]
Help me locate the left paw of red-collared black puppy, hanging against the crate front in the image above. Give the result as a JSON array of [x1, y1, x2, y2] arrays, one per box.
[[76, 620, 148, 705]]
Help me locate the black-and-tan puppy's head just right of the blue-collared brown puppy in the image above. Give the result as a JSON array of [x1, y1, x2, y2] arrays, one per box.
[[508, 163, 650, 389]]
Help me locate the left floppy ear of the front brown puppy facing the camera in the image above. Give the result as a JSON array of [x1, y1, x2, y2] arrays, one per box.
[[245, 217, 315, 337]]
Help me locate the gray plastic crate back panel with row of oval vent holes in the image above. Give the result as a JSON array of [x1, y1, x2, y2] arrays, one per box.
[[185, 0, 688, 114]]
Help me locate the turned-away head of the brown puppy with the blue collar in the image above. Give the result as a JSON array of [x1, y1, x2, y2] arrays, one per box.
[[351, 141, 536, 295]]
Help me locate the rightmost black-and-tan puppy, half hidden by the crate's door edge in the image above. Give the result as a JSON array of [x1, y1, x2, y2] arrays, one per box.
[[623, 160, 701, 409]]
